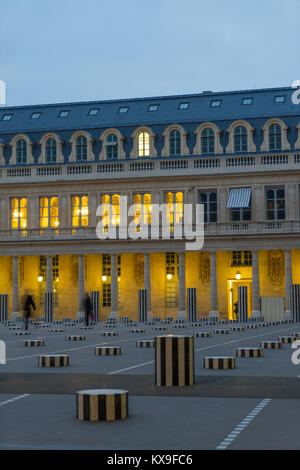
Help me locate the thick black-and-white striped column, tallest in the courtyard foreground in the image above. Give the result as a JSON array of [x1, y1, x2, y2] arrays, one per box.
[[155, 335, 195, 387]]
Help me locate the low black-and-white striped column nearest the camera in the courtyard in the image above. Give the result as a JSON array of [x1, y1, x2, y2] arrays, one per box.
[[76, 389, 128, 421]]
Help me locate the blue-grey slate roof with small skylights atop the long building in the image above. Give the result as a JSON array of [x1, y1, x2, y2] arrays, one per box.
[[0, 87, 300, 135]]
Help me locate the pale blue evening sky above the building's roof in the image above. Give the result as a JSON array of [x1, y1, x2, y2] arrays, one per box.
[[0, 0, 300, 106]]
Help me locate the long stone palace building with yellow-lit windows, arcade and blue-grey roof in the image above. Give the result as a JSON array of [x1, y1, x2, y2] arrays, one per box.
[[0, 88, 300, 320]]
